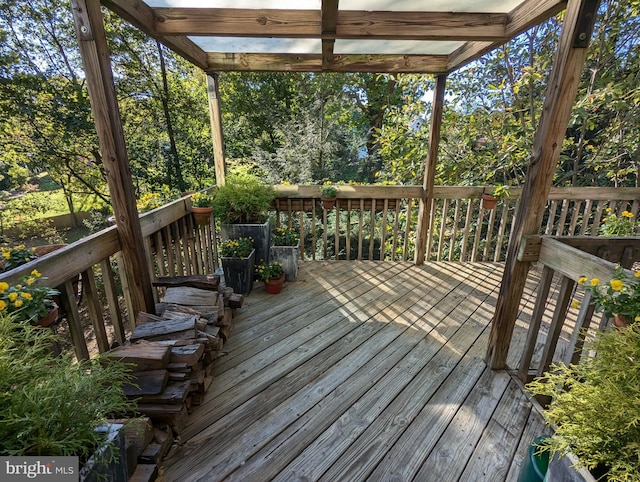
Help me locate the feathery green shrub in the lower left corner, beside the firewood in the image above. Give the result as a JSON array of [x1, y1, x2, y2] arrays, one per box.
[[0, 313, 135, 460]]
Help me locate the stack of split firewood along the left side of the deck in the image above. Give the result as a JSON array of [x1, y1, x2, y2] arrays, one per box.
[[102, 276, 243, 481]]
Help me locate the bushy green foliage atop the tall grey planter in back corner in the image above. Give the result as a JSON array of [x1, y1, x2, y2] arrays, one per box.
[[213, 171, 276, 224]]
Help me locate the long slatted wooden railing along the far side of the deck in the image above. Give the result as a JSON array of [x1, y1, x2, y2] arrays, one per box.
[[274, 186, 640, 262]]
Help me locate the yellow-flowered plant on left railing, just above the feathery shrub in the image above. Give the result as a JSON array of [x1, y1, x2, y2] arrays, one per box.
[[0, 269, 59, 323]]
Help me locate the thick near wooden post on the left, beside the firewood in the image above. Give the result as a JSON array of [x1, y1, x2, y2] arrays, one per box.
[[71, 0, 154, 318]]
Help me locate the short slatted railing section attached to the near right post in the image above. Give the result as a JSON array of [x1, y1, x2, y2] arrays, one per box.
[[518, 236, 640, 383]]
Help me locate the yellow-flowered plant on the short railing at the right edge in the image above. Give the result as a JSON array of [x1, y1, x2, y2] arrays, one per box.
[[578, 266, 640, 322]]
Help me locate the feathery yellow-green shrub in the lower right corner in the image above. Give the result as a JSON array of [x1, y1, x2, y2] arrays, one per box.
[[527, 324, 640, 482]]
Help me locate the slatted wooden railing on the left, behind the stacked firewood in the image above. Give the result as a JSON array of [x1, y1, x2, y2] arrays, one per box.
[[0, 197, 217, 359]]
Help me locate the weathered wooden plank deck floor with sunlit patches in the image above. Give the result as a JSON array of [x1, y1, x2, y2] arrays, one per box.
[[162, 262, 544, 482]]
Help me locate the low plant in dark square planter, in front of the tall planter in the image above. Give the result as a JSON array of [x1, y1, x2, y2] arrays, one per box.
[[220, 238, 256, 295]]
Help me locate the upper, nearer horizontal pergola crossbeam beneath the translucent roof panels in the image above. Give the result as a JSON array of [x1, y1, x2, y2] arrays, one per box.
[[153, 8, 508, 41]]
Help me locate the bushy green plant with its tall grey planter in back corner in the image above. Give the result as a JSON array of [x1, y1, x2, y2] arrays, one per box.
[[213, 172, 276, 270]]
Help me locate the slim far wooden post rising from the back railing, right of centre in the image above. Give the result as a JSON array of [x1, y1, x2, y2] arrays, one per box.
[[414, 74, 447, 265]]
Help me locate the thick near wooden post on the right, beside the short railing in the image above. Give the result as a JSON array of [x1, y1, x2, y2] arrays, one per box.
[[486, 0, 599, 369]]
